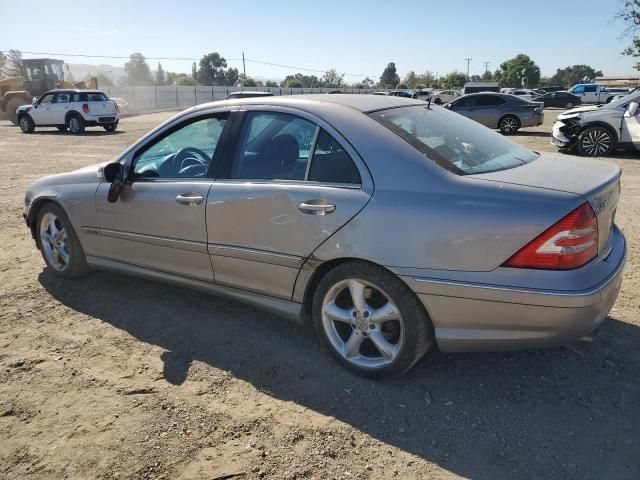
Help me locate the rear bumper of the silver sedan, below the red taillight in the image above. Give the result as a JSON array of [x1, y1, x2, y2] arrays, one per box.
[[402, 228, 626, 352]]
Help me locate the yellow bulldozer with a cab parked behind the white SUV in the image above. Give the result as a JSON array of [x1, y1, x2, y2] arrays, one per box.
[[0, 58, 98, 125]]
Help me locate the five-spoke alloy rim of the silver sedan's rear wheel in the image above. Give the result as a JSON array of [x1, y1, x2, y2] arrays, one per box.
[[322, 278, 405, 368]]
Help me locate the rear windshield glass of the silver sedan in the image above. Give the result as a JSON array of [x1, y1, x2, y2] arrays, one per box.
[[369, 106, 538, 175]]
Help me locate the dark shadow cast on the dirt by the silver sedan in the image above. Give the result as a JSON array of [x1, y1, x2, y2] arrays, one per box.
[[39, 270, 640, 479]]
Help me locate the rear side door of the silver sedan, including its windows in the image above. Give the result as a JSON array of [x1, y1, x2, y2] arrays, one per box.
[[206, 107, 373, 299]]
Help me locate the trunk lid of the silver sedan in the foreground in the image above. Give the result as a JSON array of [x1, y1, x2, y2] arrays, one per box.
[[468, 155, 621, 255]]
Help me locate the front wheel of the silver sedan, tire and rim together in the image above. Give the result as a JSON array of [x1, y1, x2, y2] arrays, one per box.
[[36, 203, 89, 278]]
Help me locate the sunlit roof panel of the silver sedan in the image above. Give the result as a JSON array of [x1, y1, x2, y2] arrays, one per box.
[[194, 93, 424, 113]]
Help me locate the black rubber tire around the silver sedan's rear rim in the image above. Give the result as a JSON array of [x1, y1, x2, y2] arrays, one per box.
[[312, 261, 434, 379]]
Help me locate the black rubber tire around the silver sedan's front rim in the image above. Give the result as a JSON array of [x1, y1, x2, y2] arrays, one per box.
[[36, 202, 90, 278]]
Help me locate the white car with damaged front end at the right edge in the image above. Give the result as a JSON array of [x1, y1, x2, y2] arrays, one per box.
[[551, 92, 640, 157]]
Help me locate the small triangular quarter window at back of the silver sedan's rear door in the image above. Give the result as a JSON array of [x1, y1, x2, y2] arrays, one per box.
[[307, 130, 362, 185]]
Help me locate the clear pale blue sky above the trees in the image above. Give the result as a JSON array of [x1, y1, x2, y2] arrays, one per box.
[[0, 0, 638, 83]]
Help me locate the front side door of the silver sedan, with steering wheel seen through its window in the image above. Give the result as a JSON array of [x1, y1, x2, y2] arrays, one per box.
[[96, 112, 229, 282]]
